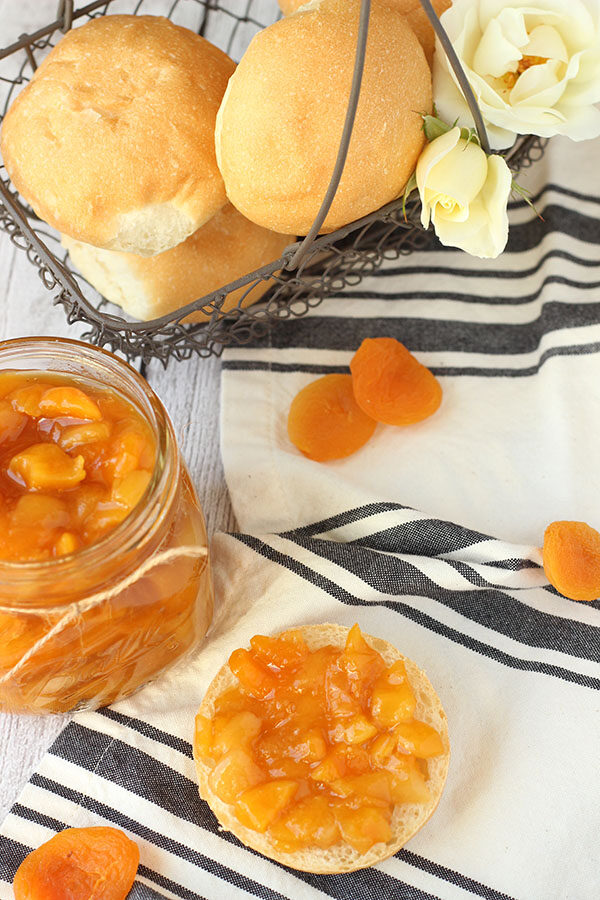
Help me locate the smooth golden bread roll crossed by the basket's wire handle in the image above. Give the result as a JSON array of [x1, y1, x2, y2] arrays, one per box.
[[216, 0, 431, 234]]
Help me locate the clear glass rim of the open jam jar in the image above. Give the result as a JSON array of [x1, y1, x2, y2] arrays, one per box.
[[0, 336, 180, 580]]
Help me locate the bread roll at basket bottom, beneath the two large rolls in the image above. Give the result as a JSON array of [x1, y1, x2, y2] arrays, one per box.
[[63, 203, 290, 322]]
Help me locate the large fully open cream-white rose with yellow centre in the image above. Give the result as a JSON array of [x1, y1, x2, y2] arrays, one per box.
[[433, 0, 600, 149]]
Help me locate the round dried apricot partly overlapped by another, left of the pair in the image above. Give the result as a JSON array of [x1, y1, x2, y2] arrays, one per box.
[[288, 375, 377, 462]]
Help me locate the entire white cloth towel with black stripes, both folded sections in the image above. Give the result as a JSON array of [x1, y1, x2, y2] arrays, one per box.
[[0, 135, 600, 900]]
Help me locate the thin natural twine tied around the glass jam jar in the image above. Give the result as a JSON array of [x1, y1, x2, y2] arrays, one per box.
[[0, 545, 208, 686]]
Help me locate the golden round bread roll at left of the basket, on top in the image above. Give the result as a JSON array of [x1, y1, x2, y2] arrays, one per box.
[[1, 15, 235, 254]]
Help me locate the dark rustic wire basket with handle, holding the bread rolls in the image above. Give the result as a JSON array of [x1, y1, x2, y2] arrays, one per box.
[[0, 0, 547, 365]]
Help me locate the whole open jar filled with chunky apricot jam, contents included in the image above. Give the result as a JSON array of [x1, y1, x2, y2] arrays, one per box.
[[0, 338, 213, 713]]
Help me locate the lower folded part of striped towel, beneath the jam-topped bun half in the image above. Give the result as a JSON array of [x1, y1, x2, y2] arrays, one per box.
[[0, 503, 600, 900]]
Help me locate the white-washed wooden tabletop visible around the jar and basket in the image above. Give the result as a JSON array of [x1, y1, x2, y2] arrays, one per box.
[[0, 0, 235, 821]]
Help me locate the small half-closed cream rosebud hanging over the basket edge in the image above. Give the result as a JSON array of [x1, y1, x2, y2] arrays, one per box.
[[416, 128, 512, 259]]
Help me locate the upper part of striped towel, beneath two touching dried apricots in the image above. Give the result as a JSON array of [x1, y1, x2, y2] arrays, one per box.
[[222, 139, 600, 544]]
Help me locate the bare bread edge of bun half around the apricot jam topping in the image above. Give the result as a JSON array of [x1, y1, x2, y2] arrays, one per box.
[[194, 624, 450, 874]]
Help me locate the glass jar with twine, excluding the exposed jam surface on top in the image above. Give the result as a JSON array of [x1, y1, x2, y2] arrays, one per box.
[[0, 338, 213, 713]]
